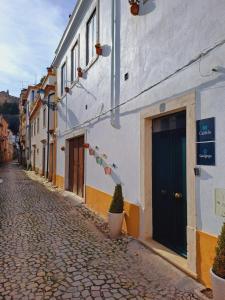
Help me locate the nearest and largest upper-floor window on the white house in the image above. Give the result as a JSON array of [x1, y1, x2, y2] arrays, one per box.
[[87, 10, 97, 65]]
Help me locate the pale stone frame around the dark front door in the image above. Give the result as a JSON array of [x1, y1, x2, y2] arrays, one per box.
[[140, 91, 197, 274]]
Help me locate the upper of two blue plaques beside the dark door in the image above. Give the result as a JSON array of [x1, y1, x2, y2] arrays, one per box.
[[197, 118, 215, 142]]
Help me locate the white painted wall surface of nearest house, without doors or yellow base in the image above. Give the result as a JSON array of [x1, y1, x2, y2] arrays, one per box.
[[57, 0, 225, 234]]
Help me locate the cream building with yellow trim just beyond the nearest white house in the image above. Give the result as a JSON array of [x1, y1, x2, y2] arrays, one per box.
[[27, 68, 56, 181]]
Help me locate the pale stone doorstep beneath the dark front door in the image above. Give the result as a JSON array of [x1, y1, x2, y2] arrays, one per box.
[[139, 239, 197, 279]]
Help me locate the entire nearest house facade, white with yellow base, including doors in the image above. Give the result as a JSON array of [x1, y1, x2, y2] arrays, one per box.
[[53, 0, 225, 286]]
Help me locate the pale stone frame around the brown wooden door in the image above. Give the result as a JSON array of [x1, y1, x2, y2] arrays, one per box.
[[64, 129, 87, 201]]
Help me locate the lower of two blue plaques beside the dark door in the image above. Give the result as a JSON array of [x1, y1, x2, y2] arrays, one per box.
[[197, 142, 215, 166]]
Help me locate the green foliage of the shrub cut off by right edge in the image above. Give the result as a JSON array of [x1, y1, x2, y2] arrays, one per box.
[[212, 223, 225, 279]]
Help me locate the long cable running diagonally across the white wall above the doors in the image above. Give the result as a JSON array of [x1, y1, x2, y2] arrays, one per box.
[[60, 39, 225, 136]]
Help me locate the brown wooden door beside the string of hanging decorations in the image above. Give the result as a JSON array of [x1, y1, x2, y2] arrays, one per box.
[[69, 136, 84, 197]]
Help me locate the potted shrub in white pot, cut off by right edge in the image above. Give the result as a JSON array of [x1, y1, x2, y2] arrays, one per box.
[[210, 223, 225, 300]]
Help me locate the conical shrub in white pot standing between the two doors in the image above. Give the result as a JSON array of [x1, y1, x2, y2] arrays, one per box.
[[108, 184, 124, 239]]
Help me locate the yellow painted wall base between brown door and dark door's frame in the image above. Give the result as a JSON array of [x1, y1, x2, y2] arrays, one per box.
[[86, 186, 139, 237]]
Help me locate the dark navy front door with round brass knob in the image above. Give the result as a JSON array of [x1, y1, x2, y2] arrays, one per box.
[[152, 112, 187, 257]]
